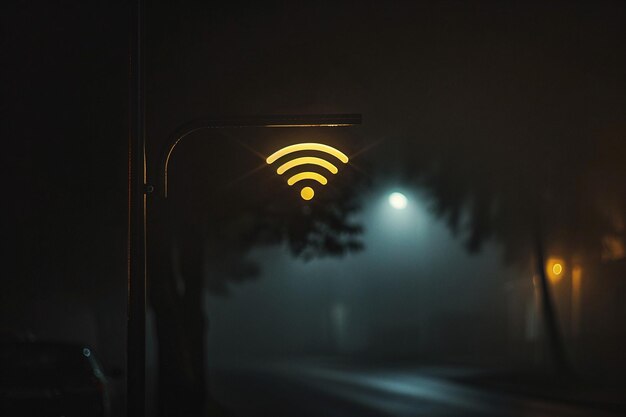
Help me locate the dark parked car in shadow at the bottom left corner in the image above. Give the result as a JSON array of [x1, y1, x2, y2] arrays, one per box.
[[0, 342, 110, 417]]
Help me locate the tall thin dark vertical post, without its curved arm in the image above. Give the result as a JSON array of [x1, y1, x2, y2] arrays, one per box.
[[126, 0, 146, 417]]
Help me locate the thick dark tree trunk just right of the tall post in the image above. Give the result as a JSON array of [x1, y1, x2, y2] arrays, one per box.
[[148, 200, 227, 417]]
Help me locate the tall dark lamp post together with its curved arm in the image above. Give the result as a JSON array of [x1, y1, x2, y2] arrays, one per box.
[[126, 4, 361, 417]]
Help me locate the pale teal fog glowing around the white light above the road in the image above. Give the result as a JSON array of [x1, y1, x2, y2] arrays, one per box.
[[207, 182, 516, 366]]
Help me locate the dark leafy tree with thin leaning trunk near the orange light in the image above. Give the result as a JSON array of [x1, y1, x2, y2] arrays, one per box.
[[394, 83, 626, 372]]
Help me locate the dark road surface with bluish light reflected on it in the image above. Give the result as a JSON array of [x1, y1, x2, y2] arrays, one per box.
[[214, 365, 621, 417]]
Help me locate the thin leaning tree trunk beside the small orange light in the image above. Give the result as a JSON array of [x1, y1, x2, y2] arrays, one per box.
[[534, 229, 570, 375]]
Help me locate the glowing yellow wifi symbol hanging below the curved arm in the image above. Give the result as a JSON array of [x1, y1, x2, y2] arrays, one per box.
[[266, 143, 348, 200]]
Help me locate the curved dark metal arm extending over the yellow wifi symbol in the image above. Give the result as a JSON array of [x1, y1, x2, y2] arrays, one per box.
[[159, 114, 361, 198]]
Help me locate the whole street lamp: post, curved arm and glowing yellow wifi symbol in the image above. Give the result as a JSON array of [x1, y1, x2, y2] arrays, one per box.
[[127, 114, 361, 417]]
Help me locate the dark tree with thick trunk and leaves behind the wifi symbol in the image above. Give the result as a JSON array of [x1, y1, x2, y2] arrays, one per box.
[[148, 129, 361, 415]]
